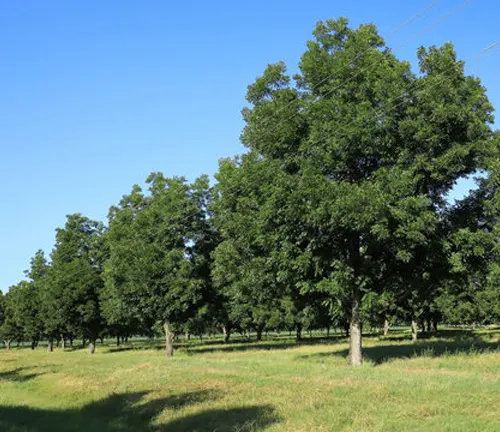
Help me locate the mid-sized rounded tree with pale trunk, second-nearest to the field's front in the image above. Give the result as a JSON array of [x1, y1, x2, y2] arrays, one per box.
[[105, 173, 208, 356]]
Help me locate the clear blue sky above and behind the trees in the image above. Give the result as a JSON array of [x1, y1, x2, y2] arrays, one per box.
[[0, 0, 500, 291]]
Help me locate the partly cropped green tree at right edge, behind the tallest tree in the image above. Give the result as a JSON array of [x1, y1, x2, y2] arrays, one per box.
[[437, 167, 500, 326]]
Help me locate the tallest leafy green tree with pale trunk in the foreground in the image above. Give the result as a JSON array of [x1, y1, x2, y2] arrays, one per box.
[[237, 19, 492, 365]]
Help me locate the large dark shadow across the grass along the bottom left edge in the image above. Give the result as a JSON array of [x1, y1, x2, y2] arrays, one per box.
[[0, 390, 279, 432]]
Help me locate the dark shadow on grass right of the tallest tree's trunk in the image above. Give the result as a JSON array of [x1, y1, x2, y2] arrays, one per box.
[[299, 330, 500, 365]]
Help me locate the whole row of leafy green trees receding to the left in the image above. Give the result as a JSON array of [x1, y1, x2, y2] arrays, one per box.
[[0, 19, 500, 365]]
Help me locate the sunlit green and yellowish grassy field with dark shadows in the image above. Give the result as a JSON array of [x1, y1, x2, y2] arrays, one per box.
[[0, 329, 500, 432]]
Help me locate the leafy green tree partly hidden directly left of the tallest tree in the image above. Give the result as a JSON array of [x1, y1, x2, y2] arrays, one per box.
[[212, 153, 292, 340]]
